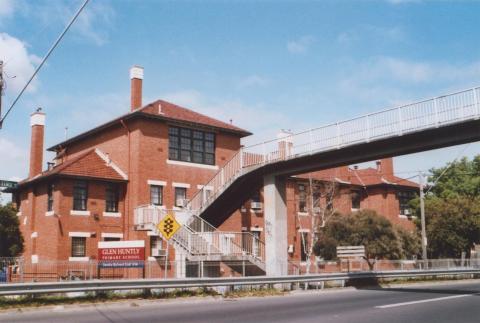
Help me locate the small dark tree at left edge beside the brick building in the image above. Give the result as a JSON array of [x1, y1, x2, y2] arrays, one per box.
[[0, 204, 23, 257]]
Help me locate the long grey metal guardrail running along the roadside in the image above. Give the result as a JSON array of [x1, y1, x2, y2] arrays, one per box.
[[0, 268, 480, 296]]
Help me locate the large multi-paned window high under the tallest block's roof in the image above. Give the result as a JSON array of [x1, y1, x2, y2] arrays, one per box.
[[168, 127, 215, 165]]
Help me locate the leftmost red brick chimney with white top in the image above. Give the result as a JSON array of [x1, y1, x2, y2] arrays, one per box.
[[28, 108, 45, 178]]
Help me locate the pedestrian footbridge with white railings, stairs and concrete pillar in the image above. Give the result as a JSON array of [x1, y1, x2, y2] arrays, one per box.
[[135, 88, 480, 275]]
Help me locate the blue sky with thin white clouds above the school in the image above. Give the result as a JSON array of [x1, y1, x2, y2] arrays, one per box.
[[0, 0, 480, 200]]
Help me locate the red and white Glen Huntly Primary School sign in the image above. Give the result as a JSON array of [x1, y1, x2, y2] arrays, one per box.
[[98, 240, 145, 262]]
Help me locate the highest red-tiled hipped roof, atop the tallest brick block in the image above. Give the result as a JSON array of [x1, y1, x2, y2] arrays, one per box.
[[47, 100, 252, 151]]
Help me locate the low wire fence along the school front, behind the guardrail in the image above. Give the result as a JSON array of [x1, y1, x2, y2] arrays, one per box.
[[0, 257, 480, 283]]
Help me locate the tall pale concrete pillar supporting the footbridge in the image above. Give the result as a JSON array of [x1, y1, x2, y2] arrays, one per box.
[[263, 175, 288, 276]]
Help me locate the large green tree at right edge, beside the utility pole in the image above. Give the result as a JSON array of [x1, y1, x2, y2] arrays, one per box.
[[411, 155, 480, 258]]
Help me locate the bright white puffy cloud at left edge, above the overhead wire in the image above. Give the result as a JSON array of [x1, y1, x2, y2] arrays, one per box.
[[0, 33, 39, 94]]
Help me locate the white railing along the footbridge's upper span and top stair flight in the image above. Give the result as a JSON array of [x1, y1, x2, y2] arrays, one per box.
[[187, 88, 480, 215]]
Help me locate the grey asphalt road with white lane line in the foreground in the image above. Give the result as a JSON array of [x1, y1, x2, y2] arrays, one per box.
[[0, 281, 480, 323]]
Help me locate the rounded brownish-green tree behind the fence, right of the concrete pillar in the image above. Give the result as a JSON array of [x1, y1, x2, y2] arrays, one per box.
[[314, 210, 418, 267]]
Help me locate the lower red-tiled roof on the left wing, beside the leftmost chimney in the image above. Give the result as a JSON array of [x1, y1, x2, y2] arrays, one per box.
[[5, 148, 128, 192]]
